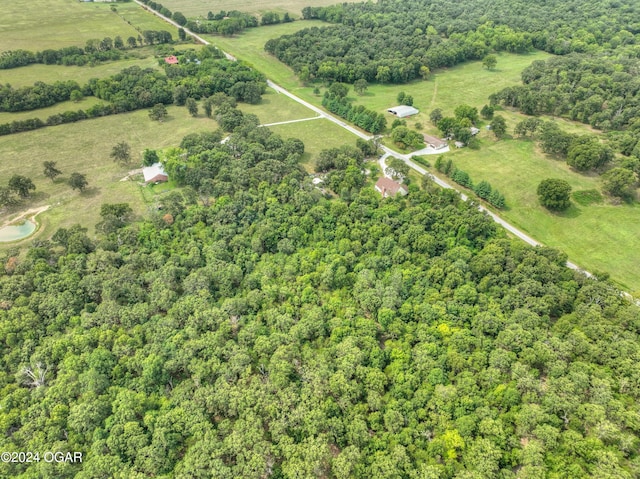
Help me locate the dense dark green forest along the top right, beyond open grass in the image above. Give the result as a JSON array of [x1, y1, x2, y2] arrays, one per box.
[[265, 0, 640, 83]]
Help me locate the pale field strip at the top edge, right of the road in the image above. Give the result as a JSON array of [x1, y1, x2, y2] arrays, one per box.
[[153, 0, 355, 18]]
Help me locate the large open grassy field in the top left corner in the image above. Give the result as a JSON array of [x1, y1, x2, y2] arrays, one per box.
[[0, 0, 178, 51]]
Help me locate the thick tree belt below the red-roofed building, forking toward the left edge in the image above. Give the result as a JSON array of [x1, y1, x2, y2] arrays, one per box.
[[0, 47, 266, 135]]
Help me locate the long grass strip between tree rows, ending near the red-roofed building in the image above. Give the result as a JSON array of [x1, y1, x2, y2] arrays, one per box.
[[2, 56, 158, 88]]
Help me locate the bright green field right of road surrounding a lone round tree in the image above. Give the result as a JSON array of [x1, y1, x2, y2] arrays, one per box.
[[442, 124, 640, 291]]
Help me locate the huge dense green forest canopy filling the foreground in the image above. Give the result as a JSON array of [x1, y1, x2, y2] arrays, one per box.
[[0, 107, 640, 479]]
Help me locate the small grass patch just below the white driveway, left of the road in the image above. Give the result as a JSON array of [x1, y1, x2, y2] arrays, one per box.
[[269, 119, 357, 173]]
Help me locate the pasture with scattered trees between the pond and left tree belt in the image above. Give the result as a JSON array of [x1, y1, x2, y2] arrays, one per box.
[[0, 107, 217, 246]]
